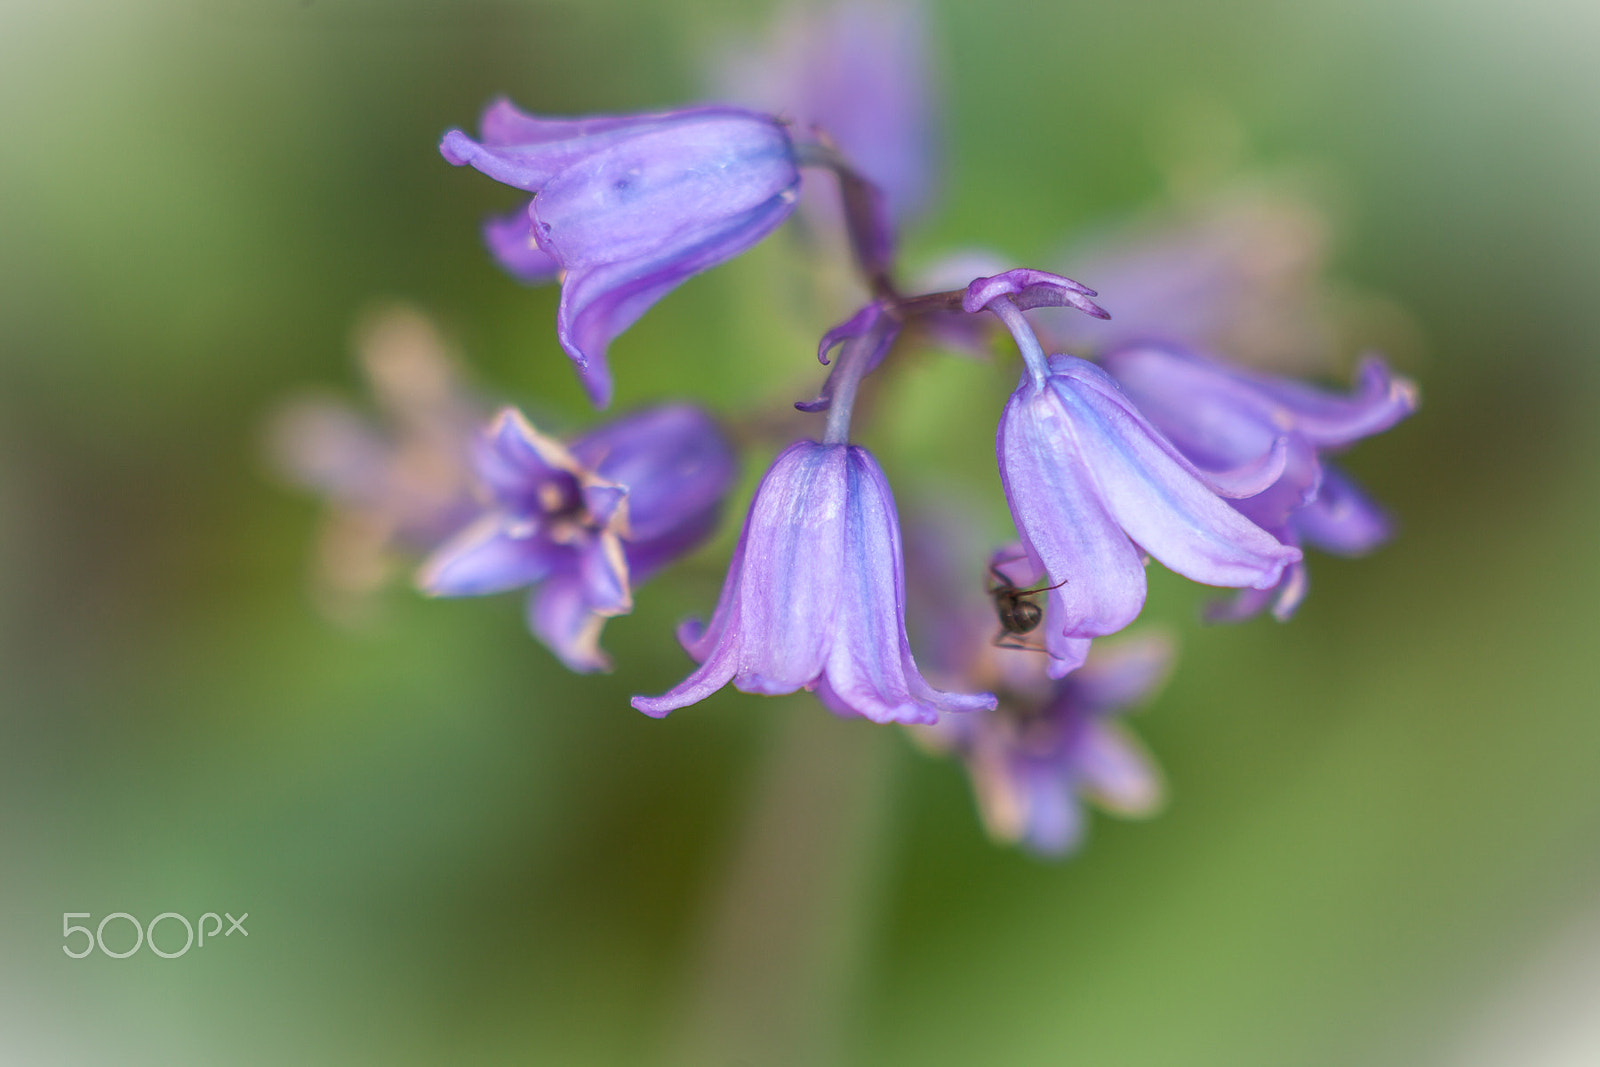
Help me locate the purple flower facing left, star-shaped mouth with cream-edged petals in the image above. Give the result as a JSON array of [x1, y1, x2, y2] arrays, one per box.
[[418, 405, 734, 672]]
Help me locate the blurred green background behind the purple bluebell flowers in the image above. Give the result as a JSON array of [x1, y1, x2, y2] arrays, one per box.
[[0, 0, 1600, 1067]]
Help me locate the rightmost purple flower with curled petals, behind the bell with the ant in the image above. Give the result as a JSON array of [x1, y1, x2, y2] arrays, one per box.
[[1102, 344, 1418, 619]]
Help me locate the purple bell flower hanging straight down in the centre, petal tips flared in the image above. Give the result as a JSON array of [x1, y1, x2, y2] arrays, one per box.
[[634, 442, 995, 723]]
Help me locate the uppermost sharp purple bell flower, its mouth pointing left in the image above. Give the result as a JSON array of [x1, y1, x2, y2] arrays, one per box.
[[438, 101, 800, 406]]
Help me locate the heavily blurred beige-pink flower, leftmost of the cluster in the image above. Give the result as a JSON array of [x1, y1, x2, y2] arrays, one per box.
[[267, 307, 483, 617]]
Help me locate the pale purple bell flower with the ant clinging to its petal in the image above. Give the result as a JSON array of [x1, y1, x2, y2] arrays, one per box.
[[997, 355, 1301, 677]]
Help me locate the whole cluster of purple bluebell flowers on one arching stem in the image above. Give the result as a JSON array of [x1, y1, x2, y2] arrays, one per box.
[[275, 6, 1416, 854]]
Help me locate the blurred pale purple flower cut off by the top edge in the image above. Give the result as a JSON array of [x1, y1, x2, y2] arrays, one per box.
[[715, 0, 936, 222]]
